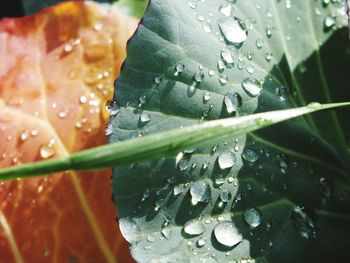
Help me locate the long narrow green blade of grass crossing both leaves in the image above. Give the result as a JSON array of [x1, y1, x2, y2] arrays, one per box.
[[0, 102, 350, 180]]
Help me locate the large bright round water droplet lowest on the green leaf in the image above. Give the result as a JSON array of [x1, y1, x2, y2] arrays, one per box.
[[214, 221, 243, 247]]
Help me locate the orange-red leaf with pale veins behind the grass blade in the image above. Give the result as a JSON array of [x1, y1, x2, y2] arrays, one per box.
[[0, 2, 137, 263]]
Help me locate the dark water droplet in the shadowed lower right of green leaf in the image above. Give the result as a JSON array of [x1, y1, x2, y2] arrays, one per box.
[[291, 206, 316, 239]]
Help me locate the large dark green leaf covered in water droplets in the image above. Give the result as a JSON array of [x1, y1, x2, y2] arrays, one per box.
[[110, 0, 350, 263]]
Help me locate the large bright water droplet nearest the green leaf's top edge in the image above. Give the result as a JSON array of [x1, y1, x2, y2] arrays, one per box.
[[219, 17, 248, 45]]
